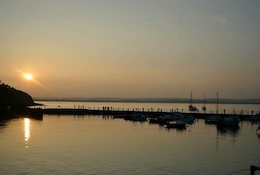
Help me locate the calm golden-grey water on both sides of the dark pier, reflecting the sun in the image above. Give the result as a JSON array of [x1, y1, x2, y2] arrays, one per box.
[[0, 101, 260, 175]]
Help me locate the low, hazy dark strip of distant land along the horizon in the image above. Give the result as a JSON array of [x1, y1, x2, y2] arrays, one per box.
[[34, 98, 260, 104]]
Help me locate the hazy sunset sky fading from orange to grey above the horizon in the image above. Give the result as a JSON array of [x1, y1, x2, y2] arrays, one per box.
[[0, 0, 260, 98]]
